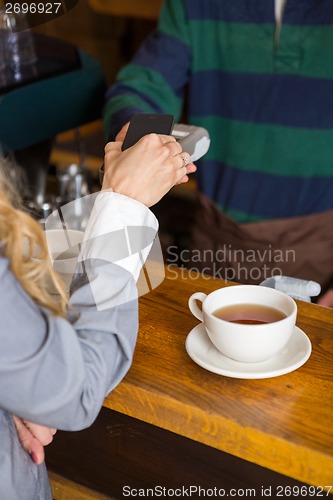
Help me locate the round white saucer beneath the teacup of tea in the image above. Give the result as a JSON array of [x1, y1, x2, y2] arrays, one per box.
[[185, 323, 311, 379]]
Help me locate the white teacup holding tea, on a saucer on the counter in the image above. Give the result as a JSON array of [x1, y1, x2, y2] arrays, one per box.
[[188, 285, 297, 363]]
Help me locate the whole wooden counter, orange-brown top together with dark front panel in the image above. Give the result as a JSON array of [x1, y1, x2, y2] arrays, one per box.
[[46, 268, 333, 500]]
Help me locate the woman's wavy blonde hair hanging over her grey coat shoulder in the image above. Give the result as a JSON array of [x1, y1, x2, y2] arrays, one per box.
[[0, 157, 68, 316]]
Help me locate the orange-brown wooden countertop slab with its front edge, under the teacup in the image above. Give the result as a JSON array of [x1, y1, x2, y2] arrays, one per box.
[[104, 268, 333, 492]]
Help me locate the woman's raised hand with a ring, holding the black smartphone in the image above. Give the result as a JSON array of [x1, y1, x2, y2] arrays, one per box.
[[102, 134, 196, 207]]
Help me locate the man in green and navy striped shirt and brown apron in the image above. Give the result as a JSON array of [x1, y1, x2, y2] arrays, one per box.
[[105, 0, 333, 305]]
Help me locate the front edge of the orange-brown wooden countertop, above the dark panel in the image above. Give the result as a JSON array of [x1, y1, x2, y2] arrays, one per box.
[[103, 381, 333, 489]]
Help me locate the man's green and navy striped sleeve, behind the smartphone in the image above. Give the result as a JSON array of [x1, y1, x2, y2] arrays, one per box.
[[104, 0, 191, 139]]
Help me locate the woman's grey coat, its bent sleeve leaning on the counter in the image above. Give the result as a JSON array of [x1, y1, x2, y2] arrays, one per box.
[[0, 254, 138, 500]]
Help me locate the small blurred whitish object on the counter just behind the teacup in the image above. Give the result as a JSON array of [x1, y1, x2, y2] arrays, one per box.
[[260, 276, 321, 302]]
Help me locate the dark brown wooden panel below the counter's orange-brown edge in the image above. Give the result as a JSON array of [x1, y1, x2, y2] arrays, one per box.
[[47, 408, 313, 499]]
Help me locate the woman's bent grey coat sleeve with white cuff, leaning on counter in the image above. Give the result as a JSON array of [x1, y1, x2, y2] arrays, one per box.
[[0, 193, 157, 430]]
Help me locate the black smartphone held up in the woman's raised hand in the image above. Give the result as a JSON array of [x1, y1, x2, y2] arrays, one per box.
[[122, 113, 174, 151]]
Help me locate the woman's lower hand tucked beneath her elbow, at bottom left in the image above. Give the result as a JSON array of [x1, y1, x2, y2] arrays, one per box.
[[13, 416, 57, 465]]
